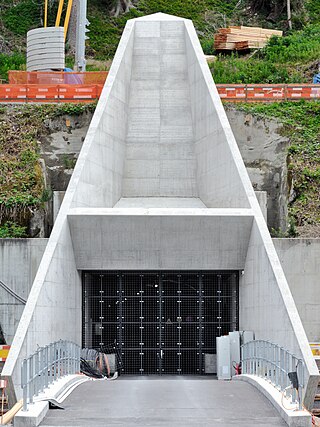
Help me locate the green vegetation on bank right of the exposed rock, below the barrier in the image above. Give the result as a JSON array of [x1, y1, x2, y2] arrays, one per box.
[[230, 101, 320, 234]]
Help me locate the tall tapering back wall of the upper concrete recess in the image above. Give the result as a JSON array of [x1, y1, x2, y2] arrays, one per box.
[[122, 21, 197, 197]]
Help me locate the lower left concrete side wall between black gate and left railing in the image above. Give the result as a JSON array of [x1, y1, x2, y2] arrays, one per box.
[[2, 218, 81, 398]]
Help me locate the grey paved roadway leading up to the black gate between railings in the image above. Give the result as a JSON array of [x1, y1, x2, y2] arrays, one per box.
[[41, 376, 286, 427]]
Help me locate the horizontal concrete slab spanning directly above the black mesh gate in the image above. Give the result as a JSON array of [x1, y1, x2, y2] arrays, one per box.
[[68, 208, 252, 270]]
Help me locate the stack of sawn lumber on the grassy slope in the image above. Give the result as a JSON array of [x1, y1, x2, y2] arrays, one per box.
[[214, 26, 282, 50]]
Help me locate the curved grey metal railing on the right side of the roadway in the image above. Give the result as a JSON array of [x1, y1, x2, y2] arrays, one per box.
[[241, 340, 305, 409]]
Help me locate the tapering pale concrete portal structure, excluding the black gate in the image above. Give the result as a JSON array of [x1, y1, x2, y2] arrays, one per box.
[[3, 13, 318, 405]]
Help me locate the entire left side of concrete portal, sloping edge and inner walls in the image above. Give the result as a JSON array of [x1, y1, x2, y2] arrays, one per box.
[[2, 18, 137, 397]]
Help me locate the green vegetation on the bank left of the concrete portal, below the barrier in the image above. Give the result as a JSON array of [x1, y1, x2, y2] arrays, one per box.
[[0, 104, 95, 237]]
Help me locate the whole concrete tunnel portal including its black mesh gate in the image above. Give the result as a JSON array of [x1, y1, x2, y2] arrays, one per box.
[[2, 14, 318, 418]]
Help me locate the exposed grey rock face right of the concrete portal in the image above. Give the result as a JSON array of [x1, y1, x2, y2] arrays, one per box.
[[227, 108, 290, 231]]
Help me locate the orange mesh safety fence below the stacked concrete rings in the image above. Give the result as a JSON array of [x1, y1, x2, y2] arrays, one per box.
[[8, 70, 108, 85]]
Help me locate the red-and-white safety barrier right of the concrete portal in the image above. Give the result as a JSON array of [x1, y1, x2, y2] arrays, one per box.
[[217, 84, 320, 102]]
